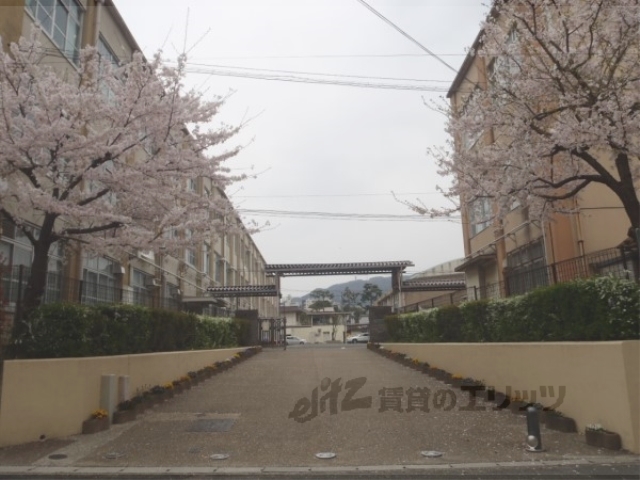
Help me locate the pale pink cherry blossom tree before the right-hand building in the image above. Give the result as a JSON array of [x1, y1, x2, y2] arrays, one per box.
[[409, 0, 640, 244]]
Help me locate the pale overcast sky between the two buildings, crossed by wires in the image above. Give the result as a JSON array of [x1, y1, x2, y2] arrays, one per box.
[[115, 0, 488, 296]]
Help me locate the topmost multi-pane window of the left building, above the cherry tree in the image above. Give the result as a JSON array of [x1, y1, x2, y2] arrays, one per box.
[[26, 0, 82, 63]]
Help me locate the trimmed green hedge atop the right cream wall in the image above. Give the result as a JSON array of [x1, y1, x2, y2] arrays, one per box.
[[385, 277, 640, 343]]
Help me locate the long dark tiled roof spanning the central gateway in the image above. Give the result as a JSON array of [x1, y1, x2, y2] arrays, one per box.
[[265, 261, 414, 276]]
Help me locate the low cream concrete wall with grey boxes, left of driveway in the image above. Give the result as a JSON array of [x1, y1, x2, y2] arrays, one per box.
[[0, 348, 243, 447]]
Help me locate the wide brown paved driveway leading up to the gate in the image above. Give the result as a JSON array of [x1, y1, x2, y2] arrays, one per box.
[[0, 345, 638, 477]]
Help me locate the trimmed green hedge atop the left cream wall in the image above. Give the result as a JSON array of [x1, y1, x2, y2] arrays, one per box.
[[12, 303, 239, 358]]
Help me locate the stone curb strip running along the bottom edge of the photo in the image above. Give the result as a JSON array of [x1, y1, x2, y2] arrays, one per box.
[[0, 456, 640, 479]]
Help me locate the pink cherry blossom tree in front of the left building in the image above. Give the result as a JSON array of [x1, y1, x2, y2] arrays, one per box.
[[0, 36, 249, 307]]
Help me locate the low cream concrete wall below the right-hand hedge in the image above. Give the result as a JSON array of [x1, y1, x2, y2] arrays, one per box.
[[383, 340, 640, 453]]
